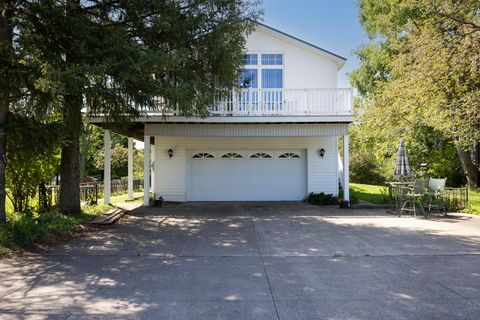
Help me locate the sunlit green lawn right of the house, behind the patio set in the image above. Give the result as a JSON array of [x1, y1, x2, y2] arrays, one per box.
[[350, 183, 480, 215]]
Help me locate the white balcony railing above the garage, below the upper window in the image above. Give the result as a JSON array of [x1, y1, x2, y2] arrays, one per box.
[[210, 89, 353, 116]]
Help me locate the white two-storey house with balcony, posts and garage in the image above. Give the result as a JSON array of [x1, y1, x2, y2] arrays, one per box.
[[89, 23, 353, 204]]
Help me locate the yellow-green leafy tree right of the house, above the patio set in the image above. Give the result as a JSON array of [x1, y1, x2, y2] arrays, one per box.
[[351, 0, 480, 187]]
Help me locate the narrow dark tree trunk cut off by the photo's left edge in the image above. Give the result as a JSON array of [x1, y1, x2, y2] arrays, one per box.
[[0, 4, 12, 224]]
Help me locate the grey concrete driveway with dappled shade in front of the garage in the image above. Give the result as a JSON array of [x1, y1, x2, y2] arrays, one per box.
[[0, 202, 480, 320]]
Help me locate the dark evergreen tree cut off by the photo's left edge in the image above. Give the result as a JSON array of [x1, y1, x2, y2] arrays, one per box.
[[0, 0, 58, 224]]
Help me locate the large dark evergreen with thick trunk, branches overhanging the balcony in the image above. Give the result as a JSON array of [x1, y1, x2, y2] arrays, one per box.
[[0, 0, 259, 213]]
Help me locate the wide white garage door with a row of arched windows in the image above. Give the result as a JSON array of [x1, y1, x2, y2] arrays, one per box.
[[187, 150, 307, 201]]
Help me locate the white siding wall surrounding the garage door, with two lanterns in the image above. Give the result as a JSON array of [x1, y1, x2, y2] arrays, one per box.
[[155, 136, 338, 201]]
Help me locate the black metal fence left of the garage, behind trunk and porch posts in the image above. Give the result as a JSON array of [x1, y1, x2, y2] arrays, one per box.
[[38, 179, 143, 209]]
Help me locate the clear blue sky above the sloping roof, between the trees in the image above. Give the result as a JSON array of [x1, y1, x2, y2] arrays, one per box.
[[263, 0, 368, 88]]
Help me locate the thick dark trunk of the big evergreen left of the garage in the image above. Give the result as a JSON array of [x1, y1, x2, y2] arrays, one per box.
[[60, 96, 82, 214]]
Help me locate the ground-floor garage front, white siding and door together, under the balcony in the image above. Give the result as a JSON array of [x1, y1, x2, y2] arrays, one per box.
[[152, 132, 339, 201]]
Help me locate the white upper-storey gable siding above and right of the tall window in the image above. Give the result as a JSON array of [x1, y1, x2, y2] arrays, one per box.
[[246, 29, 337, 89]]
